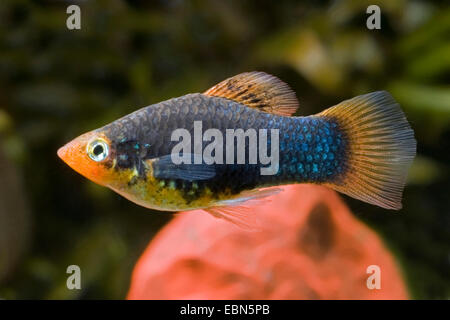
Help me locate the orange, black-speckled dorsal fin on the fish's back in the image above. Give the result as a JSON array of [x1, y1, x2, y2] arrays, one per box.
[[204, 71, 298, 116]]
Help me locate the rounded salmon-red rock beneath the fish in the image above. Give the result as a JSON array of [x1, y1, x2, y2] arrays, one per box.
[[127, 185, 408, 299]]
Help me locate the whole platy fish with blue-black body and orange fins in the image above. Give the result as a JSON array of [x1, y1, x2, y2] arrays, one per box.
[[57, 71, 416, 228]]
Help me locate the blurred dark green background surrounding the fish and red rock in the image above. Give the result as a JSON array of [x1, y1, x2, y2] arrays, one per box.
[[0, 0, 450, 299]]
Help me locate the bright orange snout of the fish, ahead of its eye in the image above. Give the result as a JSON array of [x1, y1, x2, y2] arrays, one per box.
[[57, 132, 109, 185]]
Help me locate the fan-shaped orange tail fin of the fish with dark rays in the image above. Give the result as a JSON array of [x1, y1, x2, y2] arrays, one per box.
[[320, 91, 416, 210]]
